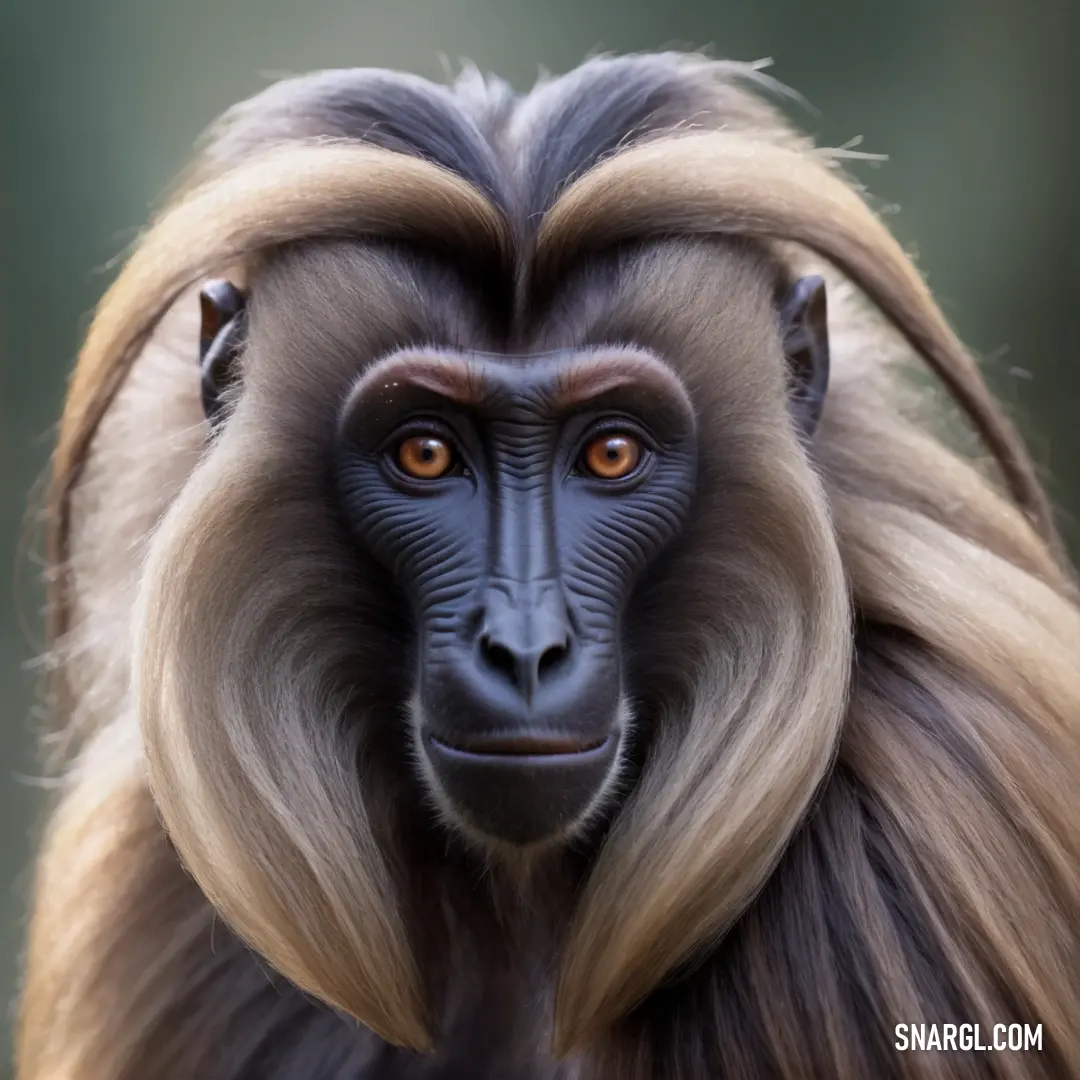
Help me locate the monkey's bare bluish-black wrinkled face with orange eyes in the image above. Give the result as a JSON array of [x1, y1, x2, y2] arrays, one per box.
[[337, 349, 694, 843]]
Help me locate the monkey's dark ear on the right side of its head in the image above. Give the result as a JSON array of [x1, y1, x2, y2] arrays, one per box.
[[780, 274, 828, 440]]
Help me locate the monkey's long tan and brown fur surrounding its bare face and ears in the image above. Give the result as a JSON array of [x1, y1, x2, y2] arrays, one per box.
[[18, 55, 1080, 1080]]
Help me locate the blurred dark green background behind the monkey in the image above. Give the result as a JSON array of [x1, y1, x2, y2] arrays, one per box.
[[0, 0, 1080, 1080]]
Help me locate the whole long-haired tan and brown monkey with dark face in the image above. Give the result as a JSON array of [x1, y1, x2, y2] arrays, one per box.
[[16, 53, 1080, 1080]]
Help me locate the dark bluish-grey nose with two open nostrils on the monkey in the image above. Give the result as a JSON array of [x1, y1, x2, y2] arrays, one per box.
[[478, 585, 573, 704]]
